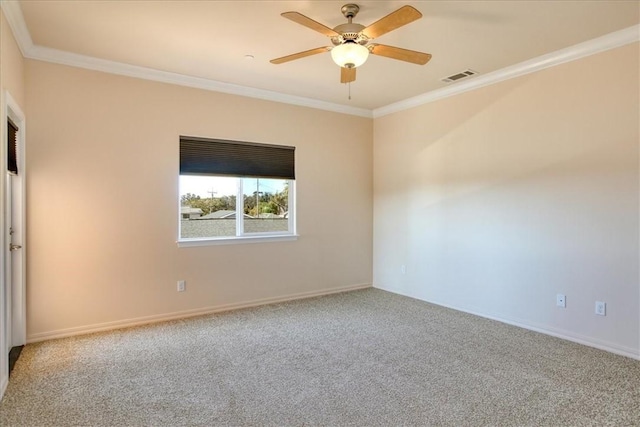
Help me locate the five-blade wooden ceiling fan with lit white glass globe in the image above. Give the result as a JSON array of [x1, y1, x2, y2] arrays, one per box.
[[271, 3, 431, 83]]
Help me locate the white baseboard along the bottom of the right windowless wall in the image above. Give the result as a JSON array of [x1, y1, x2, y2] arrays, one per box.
[[374, 286, 640, 360]]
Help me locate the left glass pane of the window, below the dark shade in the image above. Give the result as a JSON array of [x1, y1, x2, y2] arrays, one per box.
[[180, 175, 238, 239]]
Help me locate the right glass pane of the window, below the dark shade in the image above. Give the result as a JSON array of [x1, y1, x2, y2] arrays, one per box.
[[242, 178, 289, 234]]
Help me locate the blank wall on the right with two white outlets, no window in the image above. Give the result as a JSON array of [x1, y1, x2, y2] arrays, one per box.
[[373, 43, 640, 356]]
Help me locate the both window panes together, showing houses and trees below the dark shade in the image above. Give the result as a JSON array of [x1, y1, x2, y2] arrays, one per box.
[[180, 175, 293, 239]]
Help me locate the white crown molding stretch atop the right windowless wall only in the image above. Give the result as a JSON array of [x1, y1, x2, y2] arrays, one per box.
[[373, 25, 640, 118]]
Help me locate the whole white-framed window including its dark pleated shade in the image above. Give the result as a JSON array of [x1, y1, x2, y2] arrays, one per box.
[[179, 136, 295, 245]]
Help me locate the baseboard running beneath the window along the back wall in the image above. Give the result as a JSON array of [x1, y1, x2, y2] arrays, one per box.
[[27, 284, 371, 344]]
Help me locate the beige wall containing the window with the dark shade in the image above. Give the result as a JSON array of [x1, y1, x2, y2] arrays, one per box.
[[26, 60, 373, 339]]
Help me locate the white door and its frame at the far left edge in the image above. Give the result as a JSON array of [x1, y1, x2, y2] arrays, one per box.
[[0, 91, 27, 397]]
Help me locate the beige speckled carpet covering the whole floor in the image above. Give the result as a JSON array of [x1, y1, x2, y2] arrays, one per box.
[[0, 289, 640, 426]]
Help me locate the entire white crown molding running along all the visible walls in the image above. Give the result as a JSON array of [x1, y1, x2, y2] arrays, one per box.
[[0, 0, 640, 118]]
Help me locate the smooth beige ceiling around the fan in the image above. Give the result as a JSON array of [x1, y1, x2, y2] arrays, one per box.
[[8, 0, 640, 110]]
